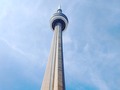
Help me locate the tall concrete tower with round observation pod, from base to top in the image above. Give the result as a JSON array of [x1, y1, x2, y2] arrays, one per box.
[[41, 8, 68, 90]]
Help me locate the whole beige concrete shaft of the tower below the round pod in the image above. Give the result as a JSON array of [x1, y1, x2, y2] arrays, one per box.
[[41, 23, 65, 90]]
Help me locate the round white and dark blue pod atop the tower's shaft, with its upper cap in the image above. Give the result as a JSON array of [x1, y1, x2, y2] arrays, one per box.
[[50, 8, 68, 31]]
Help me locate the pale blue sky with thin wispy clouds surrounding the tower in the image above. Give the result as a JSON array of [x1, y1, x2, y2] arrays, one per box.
[[0, 0, 120, 90]]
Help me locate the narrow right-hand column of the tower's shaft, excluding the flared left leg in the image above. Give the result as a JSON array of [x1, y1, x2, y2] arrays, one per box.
[[54, 23, 65, 90]]
